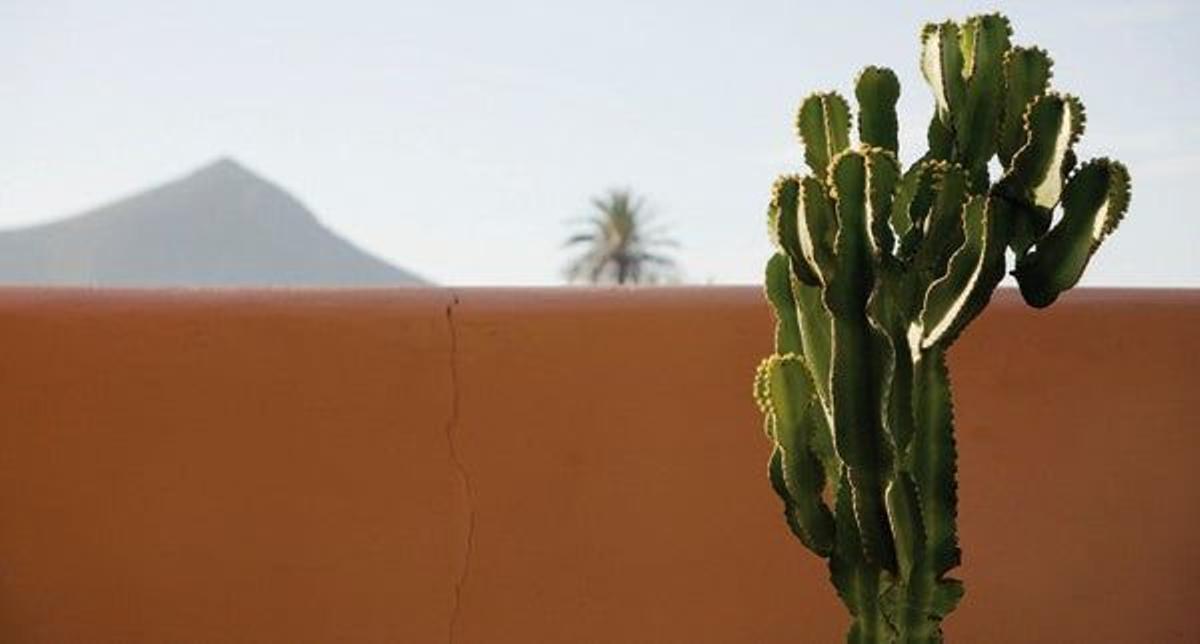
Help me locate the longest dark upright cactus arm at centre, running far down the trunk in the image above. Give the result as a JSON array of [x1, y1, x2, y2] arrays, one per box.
[[824, 151, 895, 570]]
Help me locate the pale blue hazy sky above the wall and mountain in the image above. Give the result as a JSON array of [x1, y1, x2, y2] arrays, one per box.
[[0, 0, 1200, 287]]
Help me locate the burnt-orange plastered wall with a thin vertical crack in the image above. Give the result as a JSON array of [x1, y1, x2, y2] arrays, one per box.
[[0, 288, 1200, 643]]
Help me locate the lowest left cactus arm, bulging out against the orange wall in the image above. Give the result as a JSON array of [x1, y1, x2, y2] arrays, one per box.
[[767, 354, 834, 556]]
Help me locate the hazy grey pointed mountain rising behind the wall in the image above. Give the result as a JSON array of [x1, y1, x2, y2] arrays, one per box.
[[0, 160, 425, 287]]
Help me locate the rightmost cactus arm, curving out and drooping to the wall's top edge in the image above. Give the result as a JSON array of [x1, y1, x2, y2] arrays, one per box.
[[1014, 158, 1129, 307]]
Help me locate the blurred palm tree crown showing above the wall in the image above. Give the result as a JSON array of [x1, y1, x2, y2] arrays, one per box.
[[565, 189, 678, 284]]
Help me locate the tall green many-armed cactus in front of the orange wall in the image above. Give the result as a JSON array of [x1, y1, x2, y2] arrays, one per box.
[[755, 14, 1129, 643]]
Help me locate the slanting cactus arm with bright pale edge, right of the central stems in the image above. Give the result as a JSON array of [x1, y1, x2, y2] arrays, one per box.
[[920, 195, 1008, 349]]
